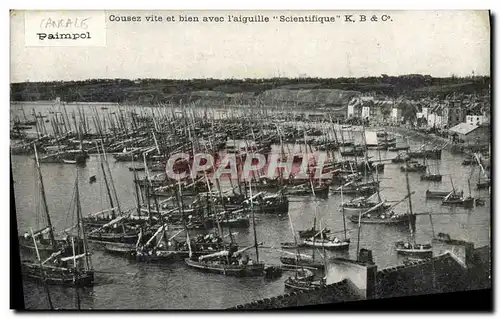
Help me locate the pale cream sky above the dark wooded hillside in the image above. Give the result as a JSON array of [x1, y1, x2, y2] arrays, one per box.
[[10, 11, 490, 83]]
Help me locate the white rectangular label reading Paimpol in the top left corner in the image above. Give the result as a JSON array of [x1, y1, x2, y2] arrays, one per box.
[[24, 10, 106, 47]]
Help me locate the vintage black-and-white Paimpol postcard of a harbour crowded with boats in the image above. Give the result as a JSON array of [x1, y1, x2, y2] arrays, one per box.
[[10, 10, 493, 310]]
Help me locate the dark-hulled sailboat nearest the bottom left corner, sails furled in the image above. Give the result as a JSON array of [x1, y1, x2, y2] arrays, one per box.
[[21, 173, 94, 287]]
